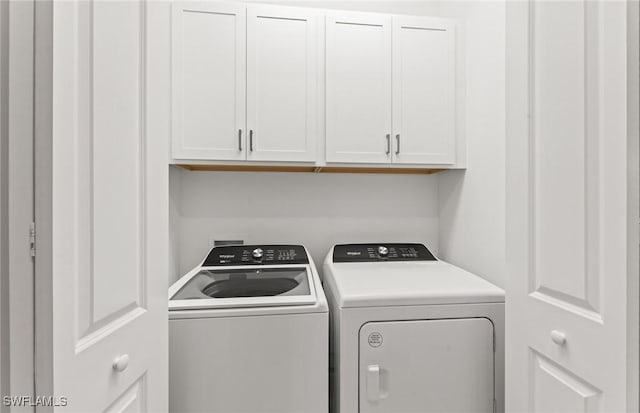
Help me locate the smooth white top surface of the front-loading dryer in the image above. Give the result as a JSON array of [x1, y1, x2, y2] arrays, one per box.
[[328, 261, 504, 307]]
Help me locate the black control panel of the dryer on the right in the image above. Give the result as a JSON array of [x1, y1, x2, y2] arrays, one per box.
[[333, 243, 436, 262]]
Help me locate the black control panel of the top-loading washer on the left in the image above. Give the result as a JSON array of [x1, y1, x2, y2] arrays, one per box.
[[203, 245, 309, 267]]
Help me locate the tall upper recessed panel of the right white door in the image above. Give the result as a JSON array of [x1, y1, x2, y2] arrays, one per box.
[[528, 2, 602, 320]]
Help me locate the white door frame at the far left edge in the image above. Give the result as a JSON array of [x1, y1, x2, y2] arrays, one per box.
[[0, 0, 35, 412]]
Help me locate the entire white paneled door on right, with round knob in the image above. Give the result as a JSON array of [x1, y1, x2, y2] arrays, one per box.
[[506, 0, 638, 412]]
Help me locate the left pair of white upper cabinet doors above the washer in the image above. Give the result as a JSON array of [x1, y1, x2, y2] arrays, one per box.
[[172, 2, 319, 162]]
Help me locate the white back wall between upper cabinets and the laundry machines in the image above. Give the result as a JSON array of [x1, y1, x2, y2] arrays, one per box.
[[170, 167, 438, 281]]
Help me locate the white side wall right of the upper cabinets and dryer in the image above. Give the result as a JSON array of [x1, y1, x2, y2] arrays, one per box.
[[438, 1, 507, 288]]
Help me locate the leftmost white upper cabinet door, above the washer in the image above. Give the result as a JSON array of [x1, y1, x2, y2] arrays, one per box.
[[171, 2, 246, 160]]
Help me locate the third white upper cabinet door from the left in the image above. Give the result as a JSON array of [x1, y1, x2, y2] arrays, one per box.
[[326, 13, 391, 163]]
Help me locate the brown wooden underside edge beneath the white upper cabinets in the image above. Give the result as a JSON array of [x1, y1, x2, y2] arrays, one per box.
[[176, 164, 449, 175]]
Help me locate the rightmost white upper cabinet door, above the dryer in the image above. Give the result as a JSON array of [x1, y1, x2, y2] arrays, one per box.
[[393, 17, 456, 164]]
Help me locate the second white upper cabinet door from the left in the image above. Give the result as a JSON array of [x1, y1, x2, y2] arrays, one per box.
[[247, 6, 318, 161]]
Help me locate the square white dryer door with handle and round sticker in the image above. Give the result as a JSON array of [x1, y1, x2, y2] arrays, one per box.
[[359, 318, 494, 413]]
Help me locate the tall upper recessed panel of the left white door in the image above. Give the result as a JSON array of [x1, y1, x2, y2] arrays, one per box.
[[71, 2, 147, 346]]
